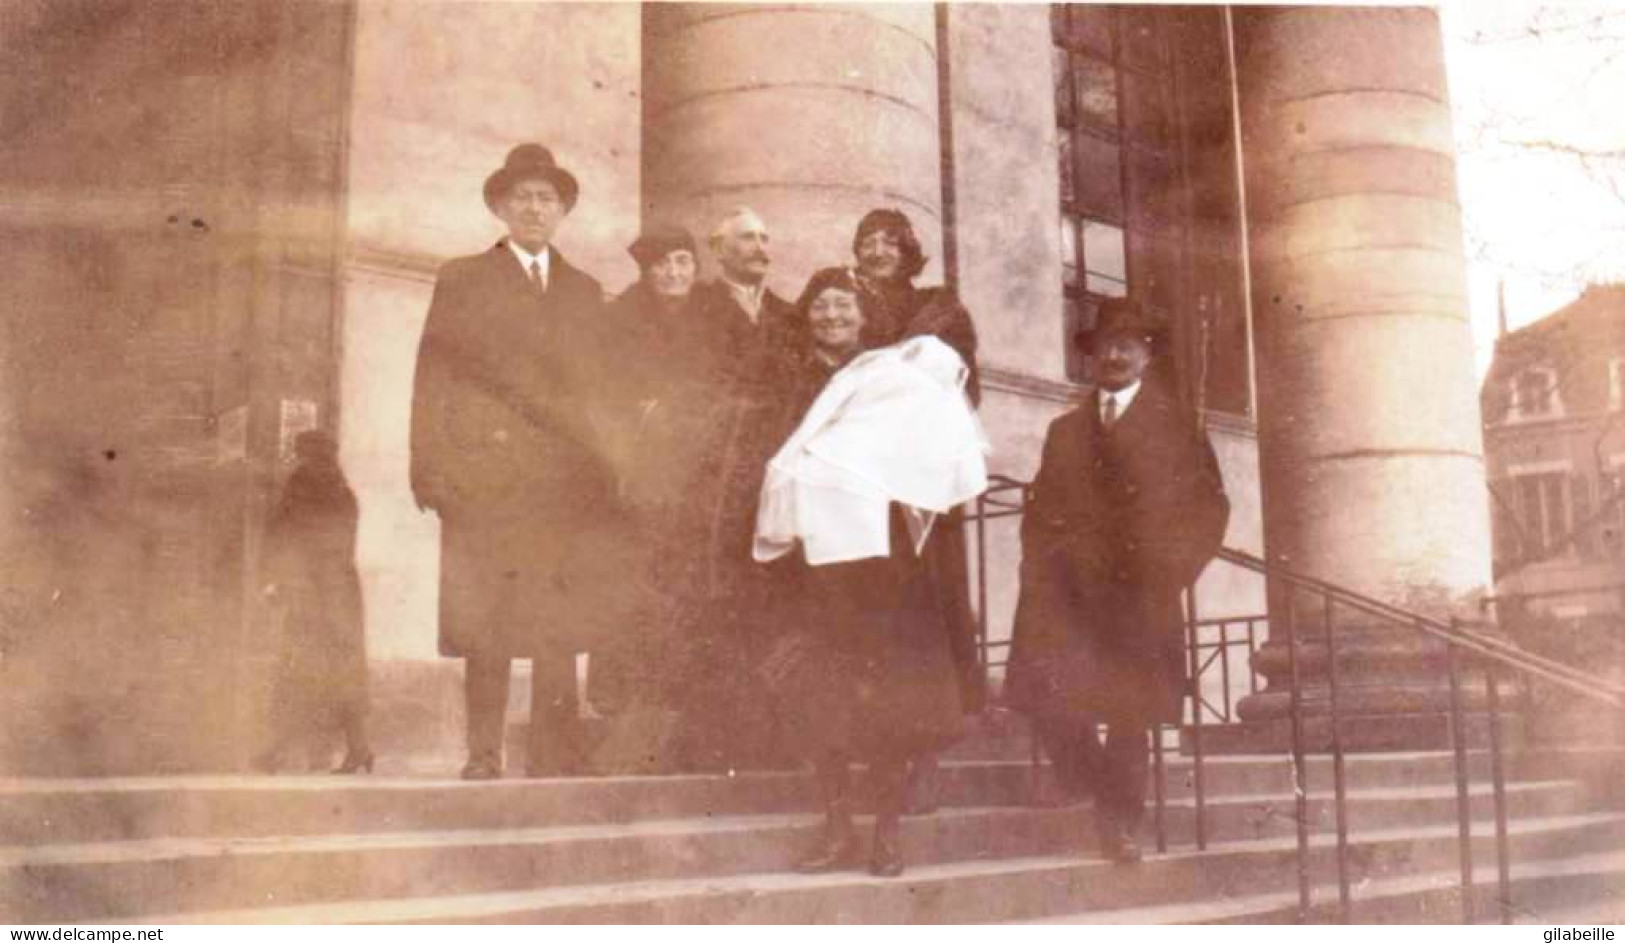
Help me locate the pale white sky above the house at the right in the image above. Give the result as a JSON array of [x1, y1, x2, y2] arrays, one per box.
[[1440, 0, 1625, 376]]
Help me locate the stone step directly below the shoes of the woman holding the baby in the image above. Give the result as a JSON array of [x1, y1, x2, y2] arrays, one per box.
[[120, 815, 1625, 923]]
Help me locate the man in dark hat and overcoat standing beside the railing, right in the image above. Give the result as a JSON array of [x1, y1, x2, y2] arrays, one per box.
[[1006, 299, 1230, 863]]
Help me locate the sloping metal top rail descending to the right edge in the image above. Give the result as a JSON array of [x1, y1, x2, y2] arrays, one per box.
[[1217, 546, 1625, 707]]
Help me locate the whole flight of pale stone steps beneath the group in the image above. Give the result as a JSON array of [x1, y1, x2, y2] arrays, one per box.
[[0, 718, 1625, 923]]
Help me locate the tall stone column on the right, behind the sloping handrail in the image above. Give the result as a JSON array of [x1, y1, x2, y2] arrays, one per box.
[[1235, 7, 1490, 745]]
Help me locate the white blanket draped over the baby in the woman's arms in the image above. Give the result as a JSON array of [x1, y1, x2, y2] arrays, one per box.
[[752, 337, 993, 566]]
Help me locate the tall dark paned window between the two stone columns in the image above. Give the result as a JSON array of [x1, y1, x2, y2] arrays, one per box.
[[1050, 3, 1251, 415]]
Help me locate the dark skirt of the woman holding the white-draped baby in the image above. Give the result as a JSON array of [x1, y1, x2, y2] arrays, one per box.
[[762, 509, 964, 761]]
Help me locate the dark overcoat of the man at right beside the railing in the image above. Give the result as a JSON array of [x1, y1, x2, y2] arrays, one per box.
[[1006, 377, 1230, 724]]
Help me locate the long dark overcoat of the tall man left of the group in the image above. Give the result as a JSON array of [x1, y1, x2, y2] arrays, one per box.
[[411, 244, 637, 657]]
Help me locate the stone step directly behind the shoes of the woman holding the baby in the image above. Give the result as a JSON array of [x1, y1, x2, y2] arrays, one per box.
[[0, 782, 1605, 922]]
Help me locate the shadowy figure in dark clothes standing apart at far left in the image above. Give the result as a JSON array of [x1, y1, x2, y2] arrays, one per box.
[[255, 432, 372, 772]]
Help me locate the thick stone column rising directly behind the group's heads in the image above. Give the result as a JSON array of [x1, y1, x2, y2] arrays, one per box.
[[642, 3, 941, 299]]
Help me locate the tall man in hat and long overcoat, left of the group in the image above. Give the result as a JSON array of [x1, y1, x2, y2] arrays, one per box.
[[411, 143, 621, 779]]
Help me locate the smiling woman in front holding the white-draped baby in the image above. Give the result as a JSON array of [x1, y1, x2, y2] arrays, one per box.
[[764, 268, 962, 876]]
